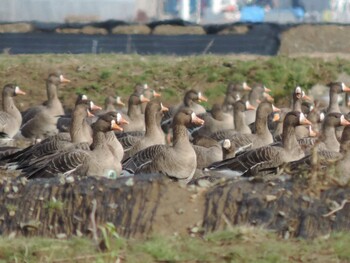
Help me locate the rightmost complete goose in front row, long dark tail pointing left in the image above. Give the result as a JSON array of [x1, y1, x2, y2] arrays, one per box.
[[208, 111, 310, 176]]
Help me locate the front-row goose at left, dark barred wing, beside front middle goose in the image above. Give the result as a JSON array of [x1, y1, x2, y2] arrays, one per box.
[[24, 112, 121, 179]]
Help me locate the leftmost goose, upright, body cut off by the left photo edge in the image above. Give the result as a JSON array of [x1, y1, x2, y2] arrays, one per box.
[[0, 84, 25, 138]]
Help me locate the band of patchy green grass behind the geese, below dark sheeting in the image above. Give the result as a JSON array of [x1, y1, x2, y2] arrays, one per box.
[[0, 54, 350, 111]]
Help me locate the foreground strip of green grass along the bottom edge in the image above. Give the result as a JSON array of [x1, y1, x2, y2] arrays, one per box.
[[0, 227, 350, 262]]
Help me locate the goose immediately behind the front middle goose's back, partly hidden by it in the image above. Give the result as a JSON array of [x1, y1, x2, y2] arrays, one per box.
[[124, 100, 168, 159]]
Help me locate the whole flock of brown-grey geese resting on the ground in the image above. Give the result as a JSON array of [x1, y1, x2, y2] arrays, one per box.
[[0, 73, 350, 186]]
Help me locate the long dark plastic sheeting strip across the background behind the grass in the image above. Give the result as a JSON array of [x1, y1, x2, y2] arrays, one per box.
[[0, 33, 280, 55]]
